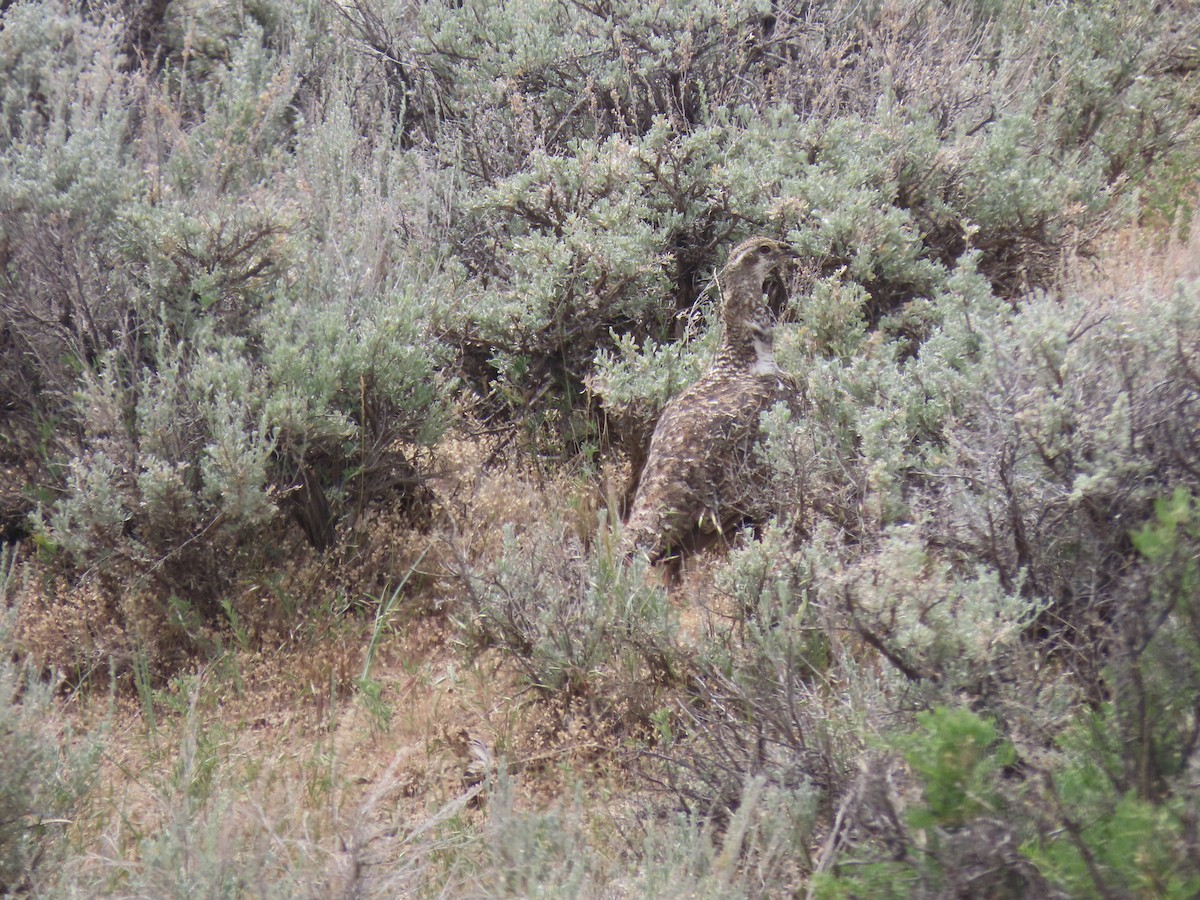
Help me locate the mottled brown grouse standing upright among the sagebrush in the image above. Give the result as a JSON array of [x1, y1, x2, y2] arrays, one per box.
[[625, 238, 792, 562]]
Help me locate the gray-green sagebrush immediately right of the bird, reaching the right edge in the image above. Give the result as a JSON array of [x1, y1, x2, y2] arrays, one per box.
[[748, 254, 1200, 631]]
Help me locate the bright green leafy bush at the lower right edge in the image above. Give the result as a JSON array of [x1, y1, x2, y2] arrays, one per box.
[[1025, 488, 1200, 896]]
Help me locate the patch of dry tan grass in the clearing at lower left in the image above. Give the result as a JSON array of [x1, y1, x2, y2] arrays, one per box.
[[14, 440, 648, 896]]
